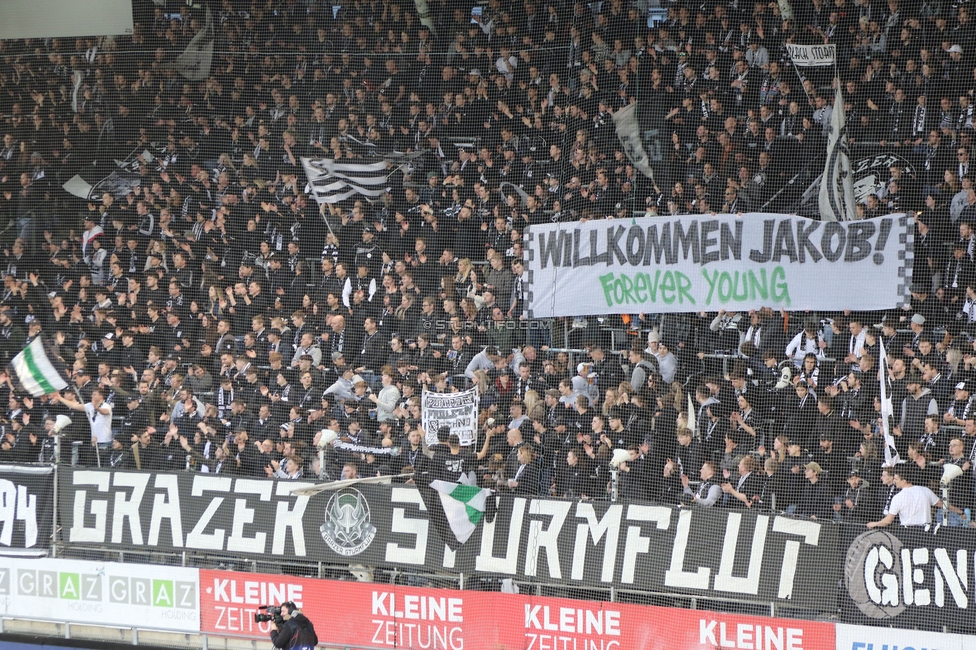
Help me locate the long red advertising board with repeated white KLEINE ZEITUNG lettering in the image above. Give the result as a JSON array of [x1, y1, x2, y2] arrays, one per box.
[[200, 570, 835, 650]]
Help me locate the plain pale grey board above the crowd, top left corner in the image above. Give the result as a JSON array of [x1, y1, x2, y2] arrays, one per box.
[[0, 0, 132, 40]]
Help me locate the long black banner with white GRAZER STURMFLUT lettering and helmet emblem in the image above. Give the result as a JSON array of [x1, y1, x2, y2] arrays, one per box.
[[58, 469, 842, 612]]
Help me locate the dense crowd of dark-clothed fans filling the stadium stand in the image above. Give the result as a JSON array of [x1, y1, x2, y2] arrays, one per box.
[[0, 0, 976, 525]]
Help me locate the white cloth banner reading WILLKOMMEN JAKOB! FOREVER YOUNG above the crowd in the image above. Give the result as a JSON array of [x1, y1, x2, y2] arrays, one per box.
[[525, 213, 914, 318]]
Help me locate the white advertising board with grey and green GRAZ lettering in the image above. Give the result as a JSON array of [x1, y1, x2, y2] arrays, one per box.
[[0, 558, 200, 632]]
